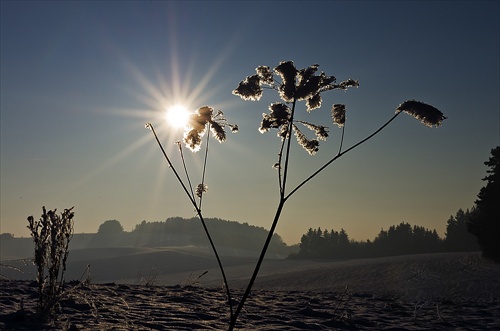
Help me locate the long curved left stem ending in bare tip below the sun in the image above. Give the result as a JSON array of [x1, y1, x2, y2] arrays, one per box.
[[148, 123, 233, 321]]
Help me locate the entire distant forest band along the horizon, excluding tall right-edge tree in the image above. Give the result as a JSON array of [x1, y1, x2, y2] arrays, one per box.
[[1, 208, 480, 259]]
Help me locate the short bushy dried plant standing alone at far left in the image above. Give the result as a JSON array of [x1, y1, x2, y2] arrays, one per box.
[[28, 207, 74, 315]]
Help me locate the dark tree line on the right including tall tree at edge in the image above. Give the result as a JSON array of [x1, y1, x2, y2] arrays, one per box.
[[290, 146, 500, 262]]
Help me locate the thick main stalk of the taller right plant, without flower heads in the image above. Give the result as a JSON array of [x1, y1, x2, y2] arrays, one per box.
[[229, 100, 295, 331]]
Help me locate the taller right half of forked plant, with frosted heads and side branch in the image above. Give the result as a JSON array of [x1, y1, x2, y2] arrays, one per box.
[[229, 61, 446, 330]]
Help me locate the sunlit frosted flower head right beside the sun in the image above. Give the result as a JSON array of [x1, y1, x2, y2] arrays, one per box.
[[183, 106, 238, 152]]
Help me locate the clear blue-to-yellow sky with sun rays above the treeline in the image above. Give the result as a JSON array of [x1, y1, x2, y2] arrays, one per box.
[[0, 1, 500, 244]]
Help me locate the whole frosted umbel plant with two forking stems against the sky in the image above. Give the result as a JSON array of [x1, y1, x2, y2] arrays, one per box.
[[146, 61, 446, 330]]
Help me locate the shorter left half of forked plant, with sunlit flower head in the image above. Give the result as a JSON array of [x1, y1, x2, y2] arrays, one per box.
[[146, 106, 238, 319]]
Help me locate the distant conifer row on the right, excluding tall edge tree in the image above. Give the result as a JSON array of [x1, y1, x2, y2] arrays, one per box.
[[289, 209, 479, 259]]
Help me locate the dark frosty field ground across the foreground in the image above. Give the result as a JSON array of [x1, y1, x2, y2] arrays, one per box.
[[0, 253, 500, 330]]
